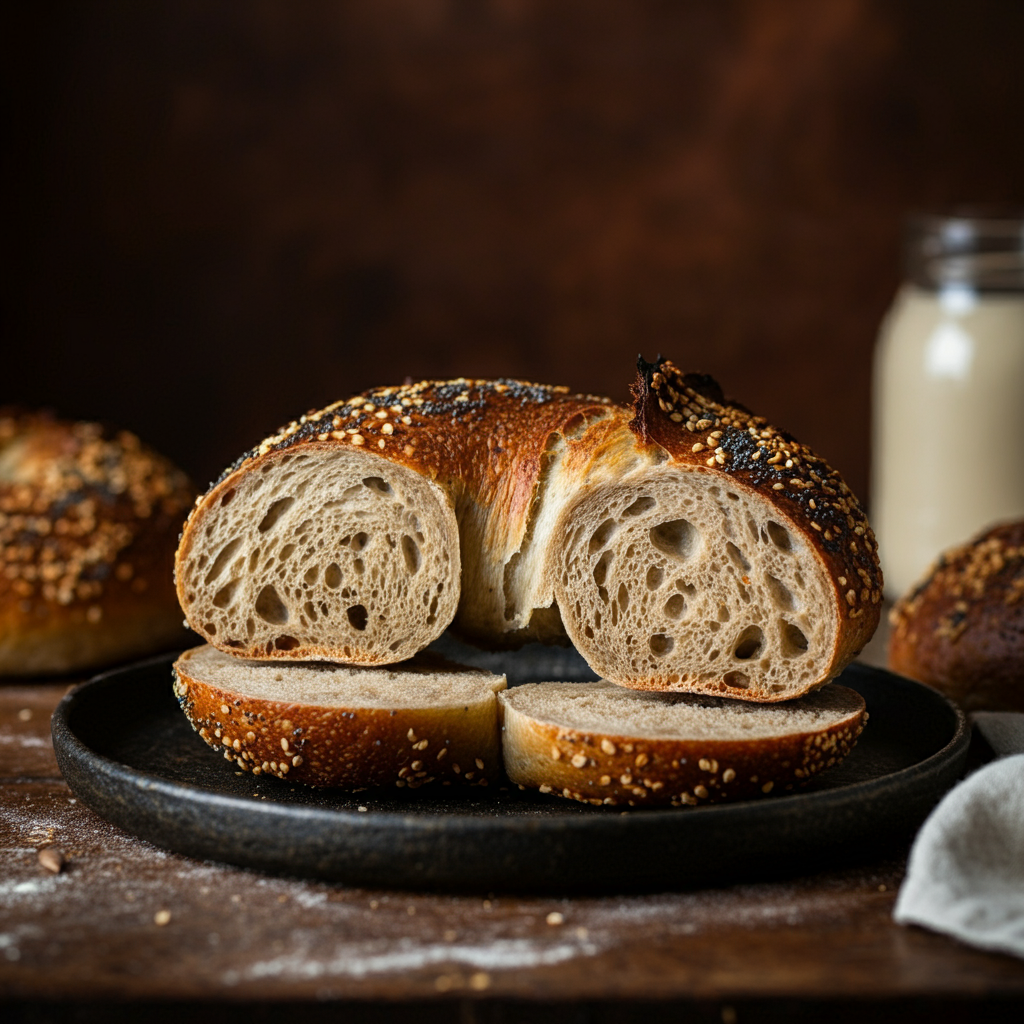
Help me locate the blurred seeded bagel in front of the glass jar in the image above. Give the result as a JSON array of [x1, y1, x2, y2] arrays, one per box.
[[889, 519, 1024, 711]]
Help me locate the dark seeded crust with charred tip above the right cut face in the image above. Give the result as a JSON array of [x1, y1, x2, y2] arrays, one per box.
[[630, 359, 882, 666]]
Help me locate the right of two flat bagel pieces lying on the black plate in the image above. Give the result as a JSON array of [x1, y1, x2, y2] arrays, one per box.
[[498, 680, 867, 807]]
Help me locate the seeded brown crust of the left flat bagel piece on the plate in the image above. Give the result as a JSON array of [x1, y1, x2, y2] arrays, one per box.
[[174, 651, 501, 790]]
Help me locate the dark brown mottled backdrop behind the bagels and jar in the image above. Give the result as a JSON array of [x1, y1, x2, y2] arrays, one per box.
[[0, 0, 1024, 494]]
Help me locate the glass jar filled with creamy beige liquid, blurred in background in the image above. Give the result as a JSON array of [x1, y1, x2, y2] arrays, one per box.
[[871, 217, 1024, 597]]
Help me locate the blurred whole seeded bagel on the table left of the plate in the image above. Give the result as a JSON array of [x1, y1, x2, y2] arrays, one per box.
[[0, 410, 195, 676]]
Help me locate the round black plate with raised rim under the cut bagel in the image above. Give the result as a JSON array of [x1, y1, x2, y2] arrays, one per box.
[[52, 647, 970, 892]]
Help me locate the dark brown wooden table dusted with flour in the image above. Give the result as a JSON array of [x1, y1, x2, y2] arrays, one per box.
[[0, 626, 1024, 1024]]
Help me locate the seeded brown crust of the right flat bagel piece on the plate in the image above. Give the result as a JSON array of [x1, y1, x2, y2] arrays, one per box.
[[499, 684, 867, 807]]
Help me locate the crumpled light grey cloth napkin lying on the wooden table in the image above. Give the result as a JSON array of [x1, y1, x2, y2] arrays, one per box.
[[893, 712, 1024, 957]]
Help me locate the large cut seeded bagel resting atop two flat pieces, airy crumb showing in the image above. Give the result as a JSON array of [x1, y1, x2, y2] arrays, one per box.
[[176, 360, 882, 701]]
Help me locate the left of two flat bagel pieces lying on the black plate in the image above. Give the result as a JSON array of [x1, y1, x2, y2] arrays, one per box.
[[174, 646, 505, 790]]
